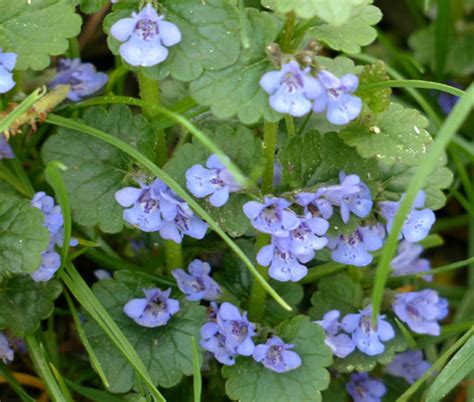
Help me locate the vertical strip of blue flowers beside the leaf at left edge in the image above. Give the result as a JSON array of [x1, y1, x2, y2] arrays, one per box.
[[31, 191, 78, 282]]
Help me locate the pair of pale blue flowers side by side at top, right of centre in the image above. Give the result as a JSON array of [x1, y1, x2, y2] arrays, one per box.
[[260, 61, 362, 125]]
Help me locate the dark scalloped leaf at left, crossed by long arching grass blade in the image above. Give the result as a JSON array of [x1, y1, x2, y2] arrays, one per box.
[[42, 105, 155, 233]]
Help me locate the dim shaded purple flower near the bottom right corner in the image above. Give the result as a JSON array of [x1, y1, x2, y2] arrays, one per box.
[[384, 350, 431, 384]]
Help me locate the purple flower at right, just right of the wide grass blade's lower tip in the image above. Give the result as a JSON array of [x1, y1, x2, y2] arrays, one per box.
[[392, 289, 448, 336]]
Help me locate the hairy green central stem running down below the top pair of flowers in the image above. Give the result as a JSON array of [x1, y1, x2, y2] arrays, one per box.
[[248, 122, 278, 321]]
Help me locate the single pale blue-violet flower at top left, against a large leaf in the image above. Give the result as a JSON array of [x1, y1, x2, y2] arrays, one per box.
[[110, 3, 181, 67]]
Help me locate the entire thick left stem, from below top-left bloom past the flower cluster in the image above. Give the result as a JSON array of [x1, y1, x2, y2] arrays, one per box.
[[138, 73, 183, 271]]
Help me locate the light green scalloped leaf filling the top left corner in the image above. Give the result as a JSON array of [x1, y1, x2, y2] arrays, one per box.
[[0, 0, 82, 70]]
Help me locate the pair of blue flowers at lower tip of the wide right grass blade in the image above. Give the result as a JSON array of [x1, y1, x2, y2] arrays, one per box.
[[316, 305, 395, 358]]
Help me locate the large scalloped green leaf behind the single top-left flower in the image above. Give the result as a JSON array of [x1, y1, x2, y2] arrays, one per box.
[[104, 0, 240, 81]]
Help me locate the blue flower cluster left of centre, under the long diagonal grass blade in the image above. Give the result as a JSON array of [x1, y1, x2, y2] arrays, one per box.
[[115, 179, 207, 243]]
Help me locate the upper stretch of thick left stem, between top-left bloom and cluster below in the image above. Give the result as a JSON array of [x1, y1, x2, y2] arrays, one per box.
[[138, 73, 168, 167]]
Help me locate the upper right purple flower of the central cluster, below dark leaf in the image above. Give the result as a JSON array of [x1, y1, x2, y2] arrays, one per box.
[[316, 171, 373, 223]]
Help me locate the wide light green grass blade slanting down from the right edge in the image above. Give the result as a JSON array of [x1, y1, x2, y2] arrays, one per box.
[[372, 84, 474, 323]]
